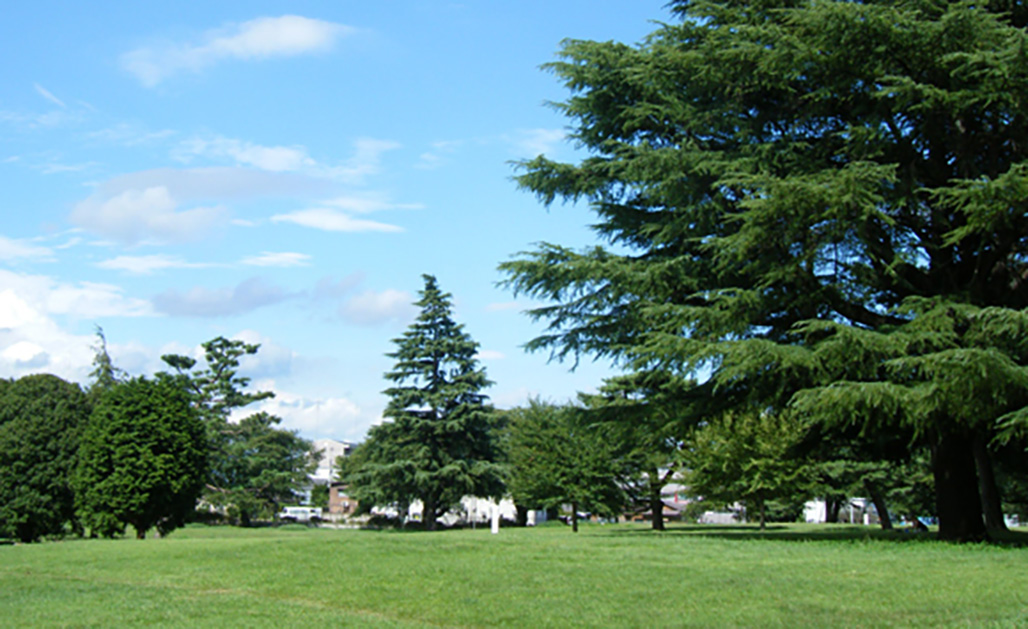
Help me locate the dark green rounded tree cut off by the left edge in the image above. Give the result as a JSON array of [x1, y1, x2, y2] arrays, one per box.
[[0, 375, 90, 542]]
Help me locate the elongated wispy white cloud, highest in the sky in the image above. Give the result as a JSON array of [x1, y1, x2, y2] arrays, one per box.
[[121, 15, 354, 87]]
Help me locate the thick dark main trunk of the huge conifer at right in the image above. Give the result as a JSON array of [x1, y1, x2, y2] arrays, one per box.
[[931, 433, 988, 542]]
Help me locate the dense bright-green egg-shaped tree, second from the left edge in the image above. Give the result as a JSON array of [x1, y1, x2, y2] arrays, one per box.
[[74, 378, 207, 539]]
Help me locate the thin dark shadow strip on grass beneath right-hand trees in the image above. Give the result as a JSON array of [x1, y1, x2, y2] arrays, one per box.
[[594, 524, 1028, 548]]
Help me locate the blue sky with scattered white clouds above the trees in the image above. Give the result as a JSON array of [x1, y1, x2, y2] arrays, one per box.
[[0, 0, 669, 441]]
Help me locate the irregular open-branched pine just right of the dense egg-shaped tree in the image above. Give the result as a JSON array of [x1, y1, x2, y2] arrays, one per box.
[[161, 336, 318, 525]]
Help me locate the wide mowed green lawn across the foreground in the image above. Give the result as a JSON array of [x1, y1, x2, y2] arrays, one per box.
[[0, 524, 1028, 628]]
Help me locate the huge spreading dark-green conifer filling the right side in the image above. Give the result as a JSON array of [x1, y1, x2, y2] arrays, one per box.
[[503, 0, 1028, 540]]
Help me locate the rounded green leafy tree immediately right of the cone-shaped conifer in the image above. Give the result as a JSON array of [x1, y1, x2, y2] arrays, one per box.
[[504, 400, 627, 530]]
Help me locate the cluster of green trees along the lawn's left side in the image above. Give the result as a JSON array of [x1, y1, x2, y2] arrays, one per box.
[[0, 331, 317, 542]]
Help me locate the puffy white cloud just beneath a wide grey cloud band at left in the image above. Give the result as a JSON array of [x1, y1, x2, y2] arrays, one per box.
[[71, 186, 226, 245]]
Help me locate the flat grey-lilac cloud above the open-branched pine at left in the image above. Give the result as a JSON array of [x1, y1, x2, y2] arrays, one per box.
[[153, 278, 293, 317]]
